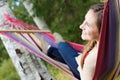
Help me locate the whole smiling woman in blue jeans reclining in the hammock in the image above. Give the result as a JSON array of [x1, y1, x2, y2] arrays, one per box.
[[40, 4, 104, 80]]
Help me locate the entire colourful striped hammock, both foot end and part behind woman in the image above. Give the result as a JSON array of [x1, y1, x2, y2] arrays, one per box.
[[0, 0, 120, 80]]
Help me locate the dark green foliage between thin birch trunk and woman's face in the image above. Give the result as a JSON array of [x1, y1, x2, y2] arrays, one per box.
[[32, 0, 98, 43]]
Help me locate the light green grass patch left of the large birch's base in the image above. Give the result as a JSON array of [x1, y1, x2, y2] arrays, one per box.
[[0, 59, 20, 80]]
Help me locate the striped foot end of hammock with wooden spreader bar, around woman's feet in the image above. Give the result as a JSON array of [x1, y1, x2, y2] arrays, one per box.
[[0, 14, 76, 79]]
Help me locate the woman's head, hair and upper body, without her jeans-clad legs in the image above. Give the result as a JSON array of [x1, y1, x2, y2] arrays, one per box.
[[76, 4, 104, 80]]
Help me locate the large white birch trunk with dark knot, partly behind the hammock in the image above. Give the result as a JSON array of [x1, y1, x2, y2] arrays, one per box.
[[0, 0, 55, 80]]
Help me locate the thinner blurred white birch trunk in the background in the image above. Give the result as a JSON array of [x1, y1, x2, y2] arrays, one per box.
[[22, 0, 48, 29]]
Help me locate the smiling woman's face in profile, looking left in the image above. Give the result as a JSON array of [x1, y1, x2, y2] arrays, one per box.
[[80, 9, 99, 41]]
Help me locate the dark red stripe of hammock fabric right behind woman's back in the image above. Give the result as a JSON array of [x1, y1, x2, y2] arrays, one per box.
[[93, 2, 109, 80]]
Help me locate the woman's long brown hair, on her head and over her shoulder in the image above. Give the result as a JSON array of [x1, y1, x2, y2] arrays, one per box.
[[80, 4, 104, 68]]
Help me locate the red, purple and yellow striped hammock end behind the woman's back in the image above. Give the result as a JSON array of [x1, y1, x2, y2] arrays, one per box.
[[93, 0, 120, 80]]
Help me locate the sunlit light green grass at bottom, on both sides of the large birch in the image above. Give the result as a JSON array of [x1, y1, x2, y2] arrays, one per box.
[[0, 59, 120, 80]]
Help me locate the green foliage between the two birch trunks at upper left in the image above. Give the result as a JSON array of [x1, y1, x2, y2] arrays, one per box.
[[8, 0, 35, 25]]
